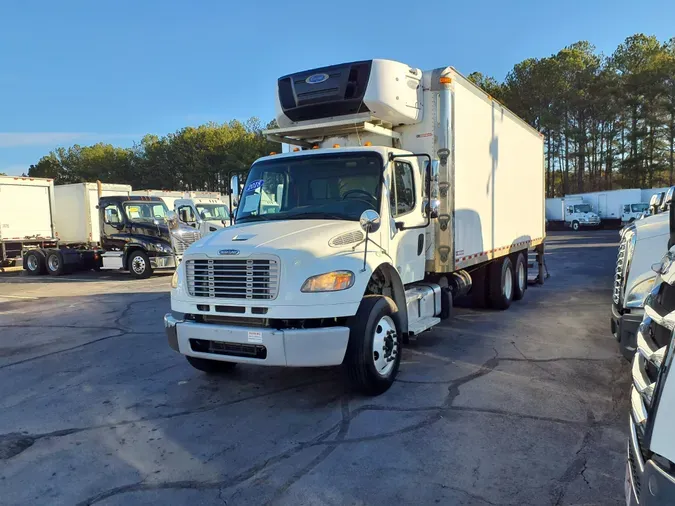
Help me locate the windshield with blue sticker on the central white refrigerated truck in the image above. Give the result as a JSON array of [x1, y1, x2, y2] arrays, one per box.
[[237, 152, 382, 222]]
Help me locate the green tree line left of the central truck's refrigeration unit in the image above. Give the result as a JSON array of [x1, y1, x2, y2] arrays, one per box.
[[28, 118, 281, 191]]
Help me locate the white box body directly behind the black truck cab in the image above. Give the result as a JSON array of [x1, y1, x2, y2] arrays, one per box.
[[54, 183, 131, 245]]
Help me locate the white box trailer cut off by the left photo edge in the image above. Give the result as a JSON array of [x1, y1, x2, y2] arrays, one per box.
[[0, 176, 56, 267]]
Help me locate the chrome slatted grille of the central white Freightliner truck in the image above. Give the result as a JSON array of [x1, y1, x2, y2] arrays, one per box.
[[186, 259, 279, 300]]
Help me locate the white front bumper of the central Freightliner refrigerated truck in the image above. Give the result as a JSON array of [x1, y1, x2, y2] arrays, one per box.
[[164, 314, 349, 367]]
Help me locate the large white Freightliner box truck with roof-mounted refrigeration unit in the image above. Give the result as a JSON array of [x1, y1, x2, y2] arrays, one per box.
[[164, 60, 545, 394]]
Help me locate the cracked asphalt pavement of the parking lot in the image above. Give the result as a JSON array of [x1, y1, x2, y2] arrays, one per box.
[[0, 231, 630, 506]]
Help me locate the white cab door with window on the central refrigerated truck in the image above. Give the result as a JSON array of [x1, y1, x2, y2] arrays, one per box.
[[388, 158, 426, 284]]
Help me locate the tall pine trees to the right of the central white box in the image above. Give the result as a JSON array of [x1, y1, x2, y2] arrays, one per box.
[[469, 34, 675, 197]]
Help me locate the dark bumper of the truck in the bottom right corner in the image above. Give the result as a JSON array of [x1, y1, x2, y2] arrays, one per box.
[[625, 418, 675, 506]]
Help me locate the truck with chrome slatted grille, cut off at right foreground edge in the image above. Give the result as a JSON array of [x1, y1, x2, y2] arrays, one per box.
[[625, 204, 675, 506]]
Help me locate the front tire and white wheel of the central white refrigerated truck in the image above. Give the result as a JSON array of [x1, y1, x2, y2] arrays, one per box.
[[345, 295, 402, 395]]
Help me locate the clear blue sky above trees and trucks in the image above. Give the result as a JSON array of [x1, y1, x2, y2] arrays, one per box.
[[0, 0, 675, 174]]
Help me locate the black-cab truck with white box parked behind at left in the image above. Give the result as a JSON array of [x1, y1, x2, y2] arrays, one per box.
[[23, 183, 200, 278]]
